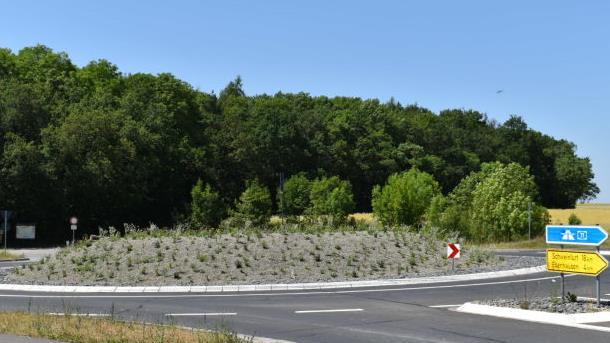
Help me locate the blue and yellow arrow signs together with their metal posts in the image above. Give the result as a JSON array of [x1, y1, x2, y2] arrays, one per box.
[[545, 225, 608, 306]]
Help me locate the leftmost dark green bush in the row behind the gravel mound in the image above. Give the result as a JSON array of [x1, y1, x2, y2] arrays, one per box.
[[191, 179, 226, 228]]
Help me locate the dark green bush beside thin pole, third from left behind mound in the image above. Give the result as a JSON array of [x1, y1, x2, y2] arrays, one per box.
[[278, 174, 311, 216]]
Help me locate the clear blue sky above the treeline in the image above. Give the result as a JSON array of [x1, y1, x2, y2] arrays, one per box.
[[0, 0, 610, 202]]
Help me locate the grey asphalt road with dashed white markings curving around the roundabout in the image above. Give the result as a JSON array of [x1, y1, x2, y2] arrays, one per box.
[[0, 252, 610, 343]]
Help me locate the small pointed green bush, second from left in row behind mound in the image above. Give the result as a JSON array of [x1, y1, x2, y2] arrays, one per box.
[[235, 180, 271, 226]]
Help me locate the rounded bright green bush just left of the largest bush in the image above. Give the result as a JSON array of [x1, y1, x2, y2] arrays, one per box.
[[372, 168, 441, 226]]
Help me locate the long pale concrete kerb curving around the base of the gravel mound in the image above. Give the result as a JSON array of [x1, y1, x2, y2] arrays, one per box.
[[0, 266, 546, 293]]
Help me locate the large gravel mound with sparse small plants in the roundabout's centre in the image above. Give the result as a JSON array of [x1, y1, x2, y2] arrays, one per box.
[[0, 231, 544, 286]]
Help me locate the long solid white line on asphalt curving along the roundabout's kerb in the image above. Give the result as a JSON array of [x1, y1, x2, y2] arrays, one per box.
[[0, 274, 564, 299]]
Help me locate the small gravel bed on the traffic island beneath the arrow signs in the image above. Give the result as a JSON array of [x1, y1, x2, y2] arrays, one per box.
[[477, 297, 610, 314]]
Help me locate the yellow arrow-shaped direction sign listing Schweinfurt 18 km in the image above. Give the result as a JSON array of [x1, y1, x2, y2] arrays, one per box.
[[546, 249, 608, 276]]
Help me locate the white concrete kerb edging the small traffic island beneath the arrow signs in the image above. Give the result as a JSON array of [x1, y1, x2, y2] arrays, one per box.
[[455, 303, 610, 332]]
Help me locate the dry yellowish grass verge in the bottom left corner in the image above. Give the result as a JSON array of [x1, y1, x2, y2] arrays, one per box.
[[0, 312, 244, 343]]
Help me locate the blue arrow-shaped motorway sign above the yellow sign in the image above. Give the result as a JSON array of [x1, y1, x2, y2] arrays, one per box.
[[546, 225, 608, 246]]
